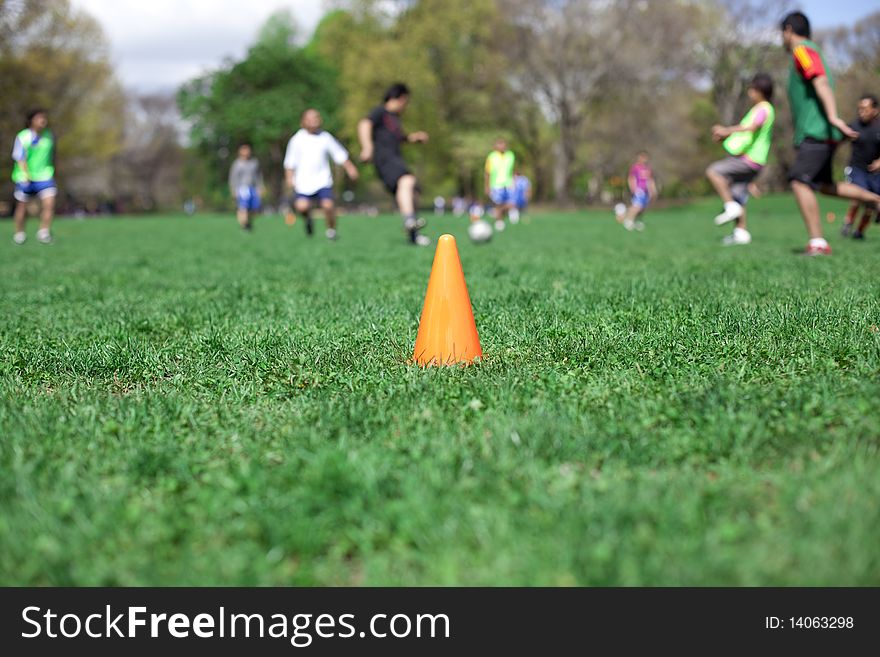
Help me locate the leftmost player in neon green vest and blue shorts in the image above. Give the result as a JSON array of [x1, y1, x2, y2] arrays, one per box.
[[12, 108, 58, 244]]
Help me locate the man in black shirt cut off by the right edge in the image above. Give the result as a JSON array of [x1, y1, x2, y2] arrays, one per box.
[[841, 94, 880, 240]]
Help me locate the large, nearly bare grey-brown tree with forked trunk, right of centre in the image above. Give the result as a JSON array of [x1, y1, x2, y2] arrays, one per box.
[[502, 0, 703, 203]]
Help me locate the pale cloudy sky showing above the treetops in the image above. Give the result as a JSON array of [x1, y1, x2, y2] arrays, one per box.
[[72, 0, 880, 93]]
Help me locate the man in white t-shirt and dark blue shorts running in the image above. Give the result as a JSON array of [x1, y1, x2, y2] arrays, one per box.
[[284, 109, 358, 240]]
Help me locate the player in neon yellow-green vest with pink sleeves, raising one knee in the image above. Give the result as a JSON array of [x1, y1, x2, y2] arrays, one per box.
[[706, 73, 776, 245]]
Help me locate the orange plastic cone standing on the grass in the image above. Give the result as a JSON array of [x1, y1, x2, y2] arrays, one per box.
[[413, 235, 483, 365]]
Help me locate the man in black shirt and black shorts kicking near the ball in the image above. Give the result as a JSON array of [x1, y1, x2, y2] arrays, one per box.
[[358, 83, 431, 246]]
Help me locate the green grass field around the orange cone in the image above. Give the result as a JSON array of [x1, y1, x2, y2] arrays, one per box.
[[0, 197, 880, 585]]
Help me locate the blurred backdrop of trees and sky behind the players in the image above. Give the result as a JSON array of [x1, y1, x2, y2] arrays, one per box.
[[0, 0, 880, 216]]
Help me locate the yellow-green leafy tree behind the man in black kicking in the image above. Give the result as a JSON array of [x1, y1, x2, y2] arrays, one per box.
[[320, 0, 513, 193]]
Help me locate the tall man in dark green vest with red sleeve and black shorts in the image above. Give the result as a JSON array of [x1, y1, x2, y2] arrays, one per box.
[[780, 11, 880, 256]]
